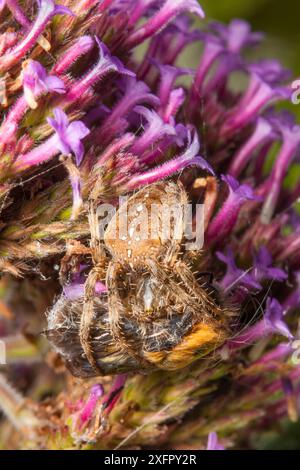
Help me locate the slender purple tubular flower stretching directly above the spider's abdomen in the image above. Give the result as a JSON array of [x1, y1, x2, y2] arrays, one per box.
[[126, 131, 214, 189]]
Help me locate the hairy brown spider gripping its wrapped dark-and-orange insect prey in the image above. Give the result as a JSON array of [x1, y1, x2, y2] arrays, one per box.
[[48, 182, 231, 376]]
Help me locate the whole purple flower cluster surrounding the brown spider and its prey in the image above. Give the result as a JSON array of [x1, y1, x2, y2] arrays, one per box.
[[0, 0, 300, 449]]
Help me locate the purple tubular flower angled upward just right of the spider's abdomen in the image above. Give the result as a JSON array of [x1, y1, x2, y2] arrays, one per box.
[[206, 175, 257, 244]]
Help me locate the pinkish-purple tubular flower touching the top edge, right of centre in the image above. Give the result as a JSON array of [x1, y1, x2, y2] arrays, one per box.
[[128, 0, 205, 48]]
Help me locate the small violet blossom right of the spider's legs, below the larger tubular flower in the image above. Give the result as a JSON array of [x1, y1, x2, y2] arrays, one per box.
[[216, 248, 262, 291]]
